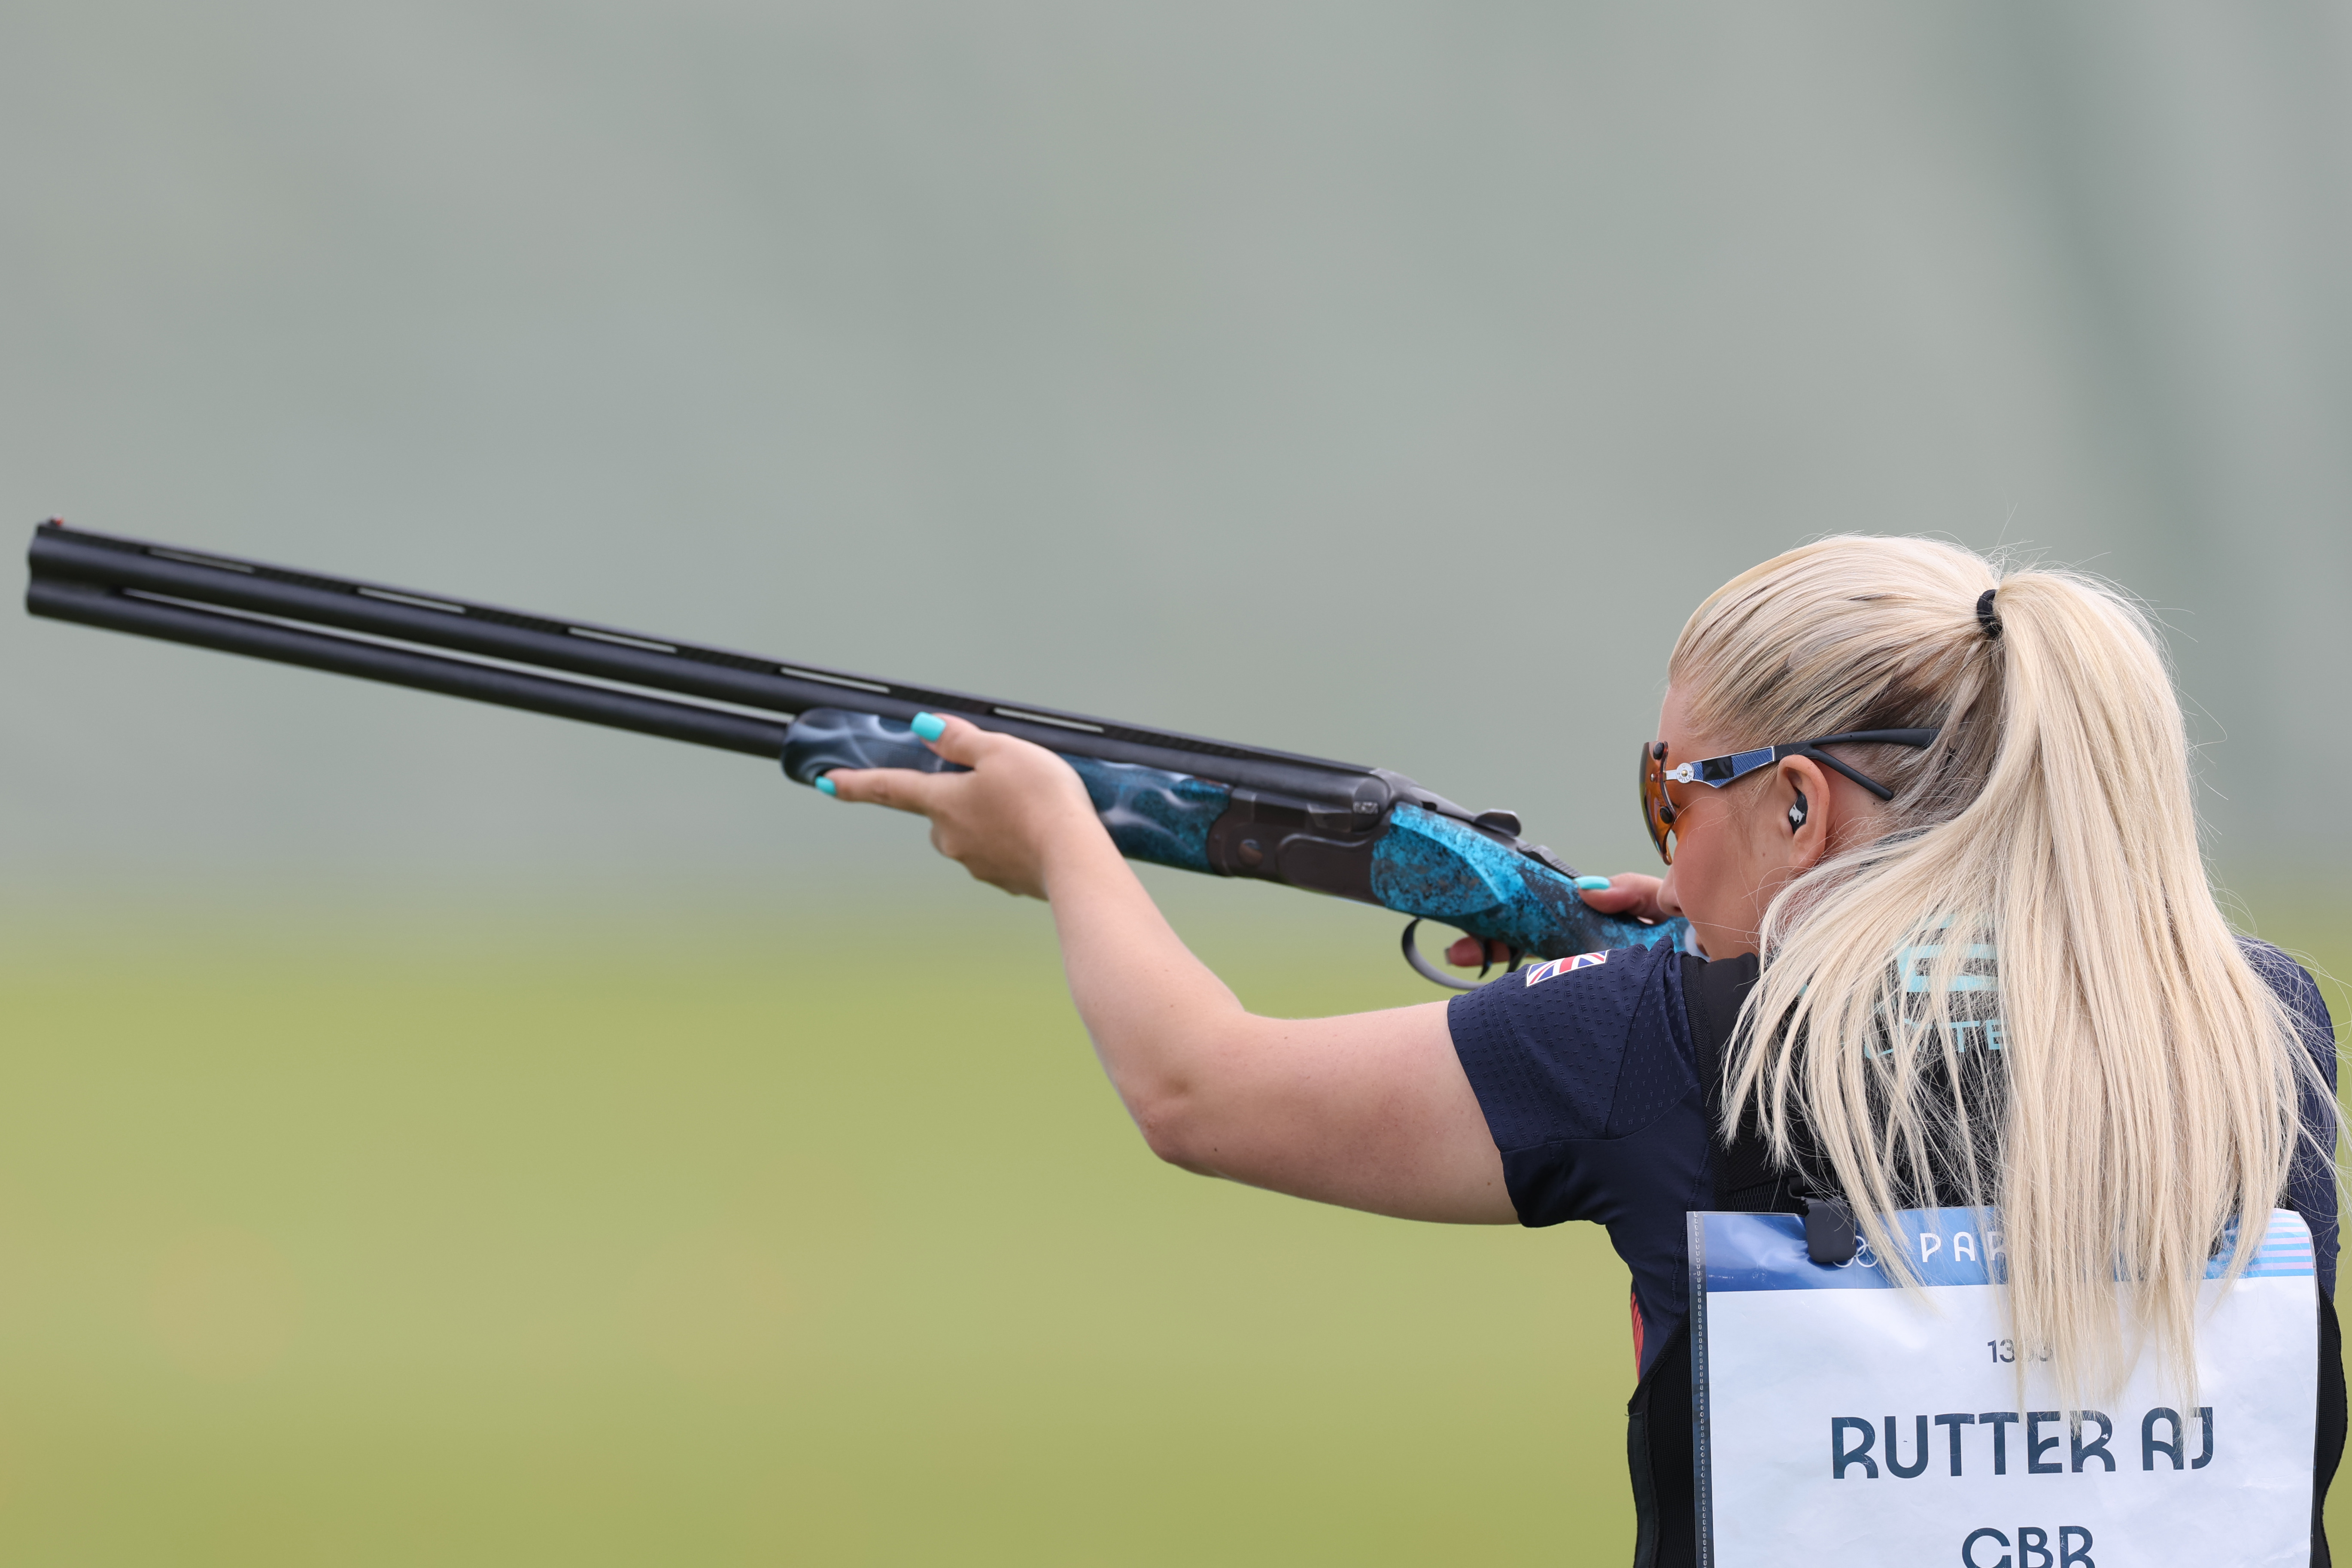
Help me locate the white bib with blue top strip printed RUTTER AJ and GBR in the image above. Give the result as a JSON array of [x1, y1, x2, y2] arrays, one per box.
[[1691, 1208, 2319, 1568]]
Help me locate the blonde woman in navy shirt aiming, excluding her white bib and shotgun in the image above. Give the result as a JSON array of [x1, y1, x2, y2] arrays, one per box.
[[833, 538, 2343, 1566]]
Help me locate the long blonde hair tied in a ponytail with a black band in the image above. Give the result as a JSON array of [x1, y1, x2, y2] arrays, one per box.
[[1670, 536, 2336, 1408]]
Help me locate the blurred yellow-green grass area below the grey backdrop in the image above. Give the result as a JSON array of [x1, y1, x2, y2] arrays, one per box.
[[0, 893, 2352, 1563]]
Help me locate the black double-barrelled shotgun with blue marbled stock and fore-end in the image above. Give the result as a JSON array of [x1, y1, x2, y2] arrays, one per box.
[[26, 522, 1687, 988]]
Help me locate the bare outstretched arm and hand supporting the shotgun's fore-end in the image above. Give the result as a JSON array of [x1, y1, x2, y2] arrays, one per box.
[[830, 719, 1517, 1225]]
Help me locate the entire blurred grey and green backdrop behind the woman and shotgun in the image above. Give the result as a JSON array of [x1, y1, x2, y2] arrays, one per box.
[[0, 0, 2352, 1563]]
